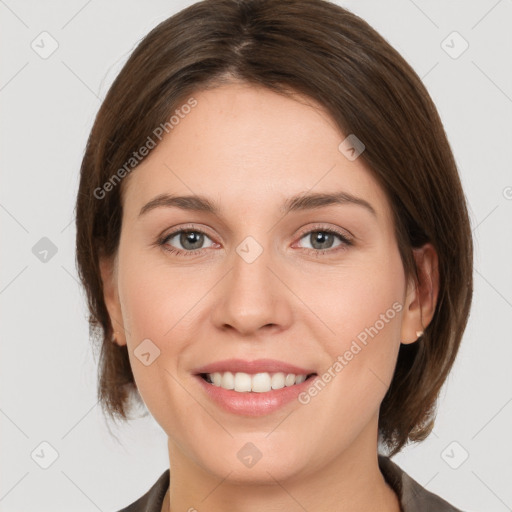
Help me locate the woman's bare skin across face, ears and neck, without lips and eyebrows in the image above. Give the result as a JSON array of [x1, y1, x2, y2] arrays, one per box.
[[101, 82, 438, 512]]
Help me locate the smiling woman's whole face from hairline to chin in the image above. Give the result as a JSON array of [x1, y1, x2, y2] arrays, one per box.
[[103, 83, 436, 481]]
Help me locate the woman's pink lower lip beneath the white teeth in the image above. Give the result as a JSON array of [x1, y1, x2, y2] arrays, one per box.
[[195, 375, 317, 416]]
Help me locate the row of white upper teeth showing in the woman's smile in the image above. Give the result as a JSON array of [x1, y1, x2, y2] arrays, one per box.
[[206, 372, 307, 393]]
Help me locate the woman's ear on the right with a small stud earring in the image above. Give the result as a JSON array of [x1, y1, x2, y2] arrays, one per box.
[[400, 243, 439, 344]]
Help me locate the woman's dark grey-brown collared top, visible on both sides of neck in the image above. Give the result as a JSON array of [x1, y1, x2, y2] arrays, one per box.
[[118, 455, 462, 512]]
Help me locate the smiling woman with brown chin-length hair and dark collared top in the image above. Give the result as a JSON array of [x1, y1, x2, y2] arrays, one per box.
[[77, 0, 473, 512]]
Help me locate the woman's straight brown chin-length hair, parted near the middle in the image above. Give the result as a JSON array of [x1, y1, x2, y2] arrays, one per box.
[[76, 0, 473, 456]]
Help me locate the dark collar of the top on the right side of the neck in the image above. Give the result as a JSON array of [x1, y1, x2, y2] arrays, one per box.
[[379, 455, 462, 512]]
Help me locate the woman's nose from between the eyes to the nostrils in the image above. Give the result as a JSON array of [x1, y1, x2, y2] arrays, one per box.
[[213, 239, 293, 336]]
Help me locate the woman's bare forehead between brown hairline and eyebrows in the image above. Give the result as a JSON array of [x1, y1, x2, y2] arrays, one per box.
[[123, 83, 390, 227]]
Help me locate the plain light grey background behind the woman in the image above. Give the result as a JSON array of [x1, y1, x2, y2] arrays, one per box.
[[0, 0, 512, 512]]
